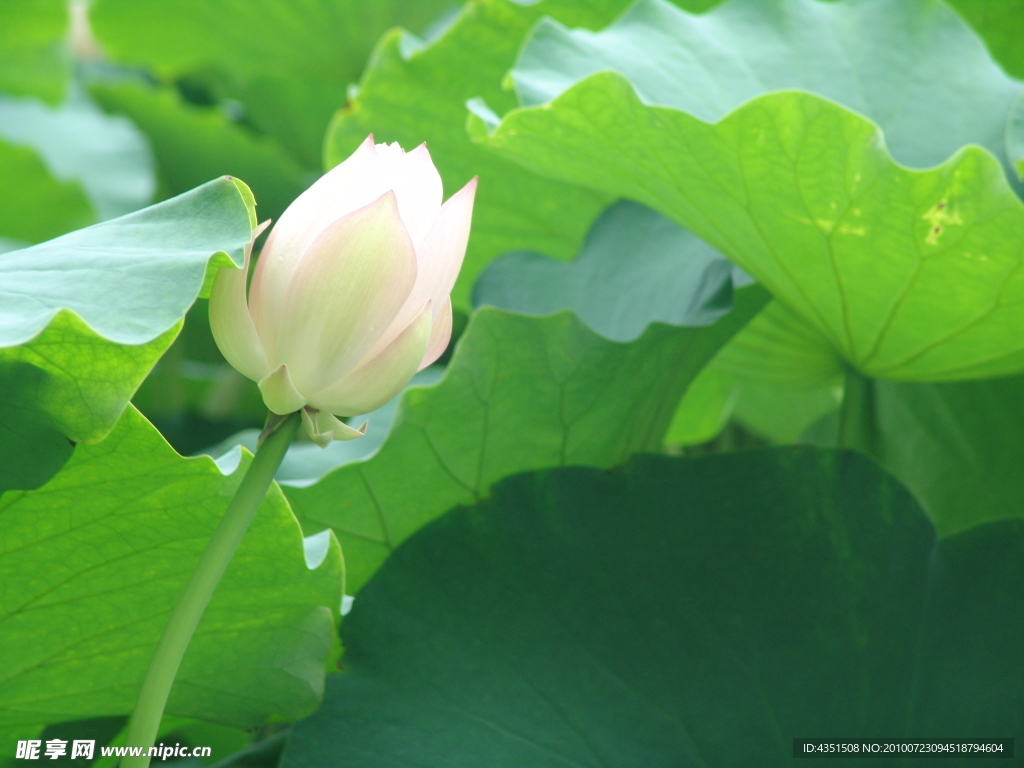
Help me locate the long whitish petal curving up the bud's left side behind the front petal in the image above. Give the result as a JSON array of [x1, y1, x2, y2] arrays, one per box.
[[249, 136, 391, 341]]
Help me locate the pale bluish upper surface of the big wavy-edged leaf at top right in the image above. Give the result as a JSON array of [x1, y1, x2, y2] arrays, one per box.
[[511, 0, 1024, 174]]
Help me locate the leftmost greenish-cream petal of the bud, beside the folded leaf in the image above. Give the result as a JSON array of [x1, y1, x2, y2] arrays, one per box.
[[210, 221, 270, 381]]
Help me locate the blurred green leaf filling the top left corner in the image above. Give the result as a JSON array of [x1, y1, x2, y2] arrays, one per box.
[[0, 0, 71, 103]]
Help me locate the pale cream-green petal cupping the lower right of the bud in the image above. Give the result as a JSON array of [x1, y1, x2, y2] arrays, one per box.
[[309, 305, 431, 416]]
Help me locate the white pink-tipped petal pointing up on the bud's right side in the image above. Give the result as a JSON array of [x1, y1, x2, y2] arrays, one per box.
[[360, 178, 476, 364]]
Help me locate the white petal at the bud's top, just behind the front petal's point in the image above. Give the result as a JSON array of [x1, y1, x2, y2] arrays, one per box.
[[377, 143, 443, 248]]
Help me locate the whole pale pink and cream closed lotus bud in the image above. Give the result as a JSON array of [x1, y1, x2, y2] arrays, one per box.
[[210, 136, 476, 445]]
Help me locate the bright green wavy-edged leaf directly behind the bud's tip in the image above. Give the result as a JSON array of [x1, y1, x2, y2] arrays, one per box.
[[326, 0, 679, 309]]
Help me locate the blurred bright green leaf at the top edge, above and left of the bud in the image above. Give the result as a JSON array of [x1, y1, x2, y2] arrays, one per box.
[[90, 0, 460, 168]]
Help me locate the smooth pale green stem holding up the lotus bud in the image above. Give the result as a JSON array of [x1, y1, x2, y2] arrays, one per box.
[[121, 414, 301, 768]]
